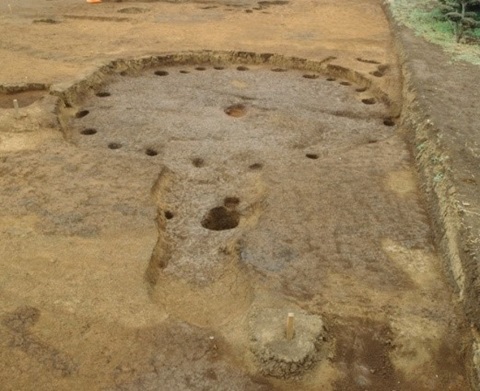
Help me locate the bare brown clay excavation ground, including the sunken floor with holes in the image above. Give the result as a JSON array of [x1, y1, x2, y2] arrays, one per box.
[[0, 0, 469, 390]]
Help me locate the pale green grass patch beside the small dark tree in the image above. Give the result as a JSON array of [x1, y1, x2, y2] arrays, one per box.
[[390, 0, 480, 65]]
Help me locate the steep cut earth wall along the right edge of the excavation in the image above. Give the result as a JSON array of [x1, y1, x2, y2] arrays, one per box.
[[383, 2, 480, 390]]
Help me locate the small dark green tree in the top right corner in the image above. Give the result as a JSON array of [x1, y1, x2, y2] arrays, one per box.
[[439, 0, 480, 42]]
